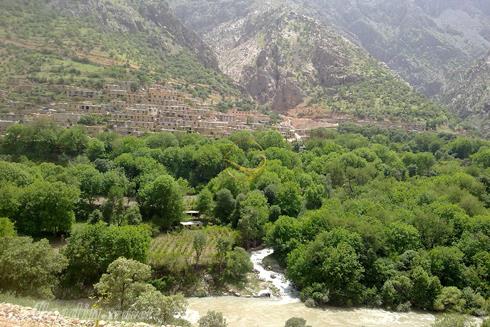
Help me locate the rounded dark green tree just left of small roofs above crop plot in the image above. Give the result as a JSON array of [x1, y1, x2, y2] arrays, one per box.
[[138, 175, 184, 229]]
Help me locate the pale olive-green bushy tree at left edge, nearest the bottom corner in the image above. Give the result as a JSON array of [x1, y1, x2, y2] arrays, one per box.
[[0, 237, 67, 298]]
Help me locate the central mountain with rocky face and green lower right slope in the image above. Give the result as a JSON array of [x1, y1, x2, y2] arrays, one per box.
[[171, 0, 446, 122]]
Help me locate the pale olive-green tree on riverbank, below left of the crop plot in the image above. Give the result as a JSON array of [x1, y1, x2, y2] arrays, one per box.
[[94, 257, 153, 312]]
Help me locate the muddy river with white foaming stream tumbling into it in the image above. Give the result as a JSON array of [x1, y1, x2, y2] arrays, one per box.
[[186, 249, 435, 327]]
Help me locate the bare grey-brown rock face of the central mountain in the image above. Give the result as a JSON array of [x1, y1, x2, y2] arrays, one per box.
[[168, 4, 398, 112]]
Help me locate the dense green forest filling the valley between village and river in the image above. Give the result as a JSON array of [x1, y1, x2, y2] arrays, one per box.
[[0, 121, 490, 323]]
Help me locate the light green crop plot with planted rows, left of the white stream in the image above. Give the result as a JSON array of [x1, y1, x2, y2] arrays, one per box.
[[149, 226, 235, 271]]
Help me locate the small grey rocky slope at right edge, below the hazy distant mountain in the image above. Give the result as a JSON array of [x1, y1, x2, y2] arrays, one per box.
[[444, 53, 490, 136]]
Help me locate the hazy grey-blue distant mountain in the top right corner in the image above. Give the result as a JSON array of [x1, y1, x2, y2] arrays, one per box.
[[291, 0, 490, 96]]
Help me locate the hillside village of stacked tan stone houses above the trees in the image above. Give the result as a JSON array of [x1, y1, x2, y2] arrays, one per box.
[[0, 83, 307, 139]]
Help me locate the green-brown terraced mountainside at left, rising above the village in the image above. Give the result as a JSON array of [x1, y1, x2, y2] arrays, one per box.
[[0, 0, 240, 109]]
